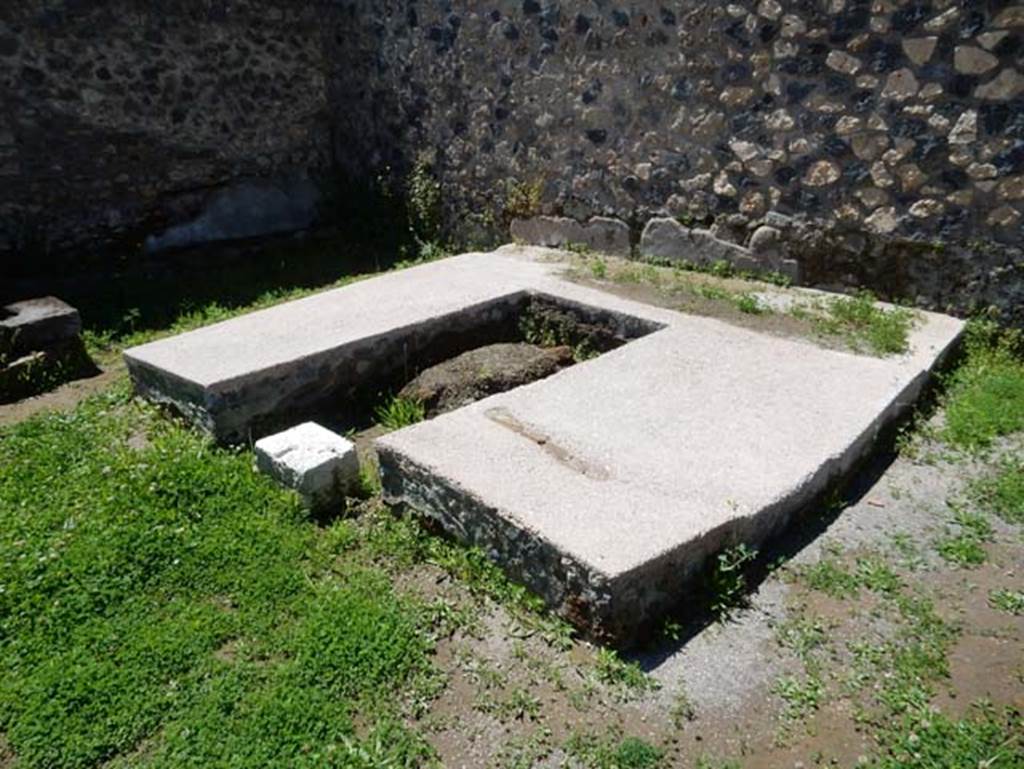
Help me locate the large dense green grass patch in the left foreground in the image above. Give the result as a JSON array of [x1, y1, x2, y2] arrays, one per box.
[[0, 386, 434, 767]]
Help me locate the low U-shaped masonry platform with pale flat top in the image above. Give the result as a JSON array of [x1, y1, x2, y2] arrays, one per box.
[[125, 247, 963, 642]]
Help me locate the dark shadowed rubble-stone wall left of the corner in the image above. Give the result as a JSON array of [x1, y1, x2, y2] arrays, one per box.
[[0, 0, 331, 274]]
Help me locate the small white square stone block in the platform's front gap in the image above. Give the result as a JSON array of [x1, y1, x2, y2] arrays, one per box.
[[255, 422, 359, 512]]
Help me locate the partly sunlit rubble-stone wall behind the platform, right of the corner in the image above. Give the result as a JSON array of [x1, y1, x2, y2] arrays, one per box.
[[330, 0, 1024, 319]]
